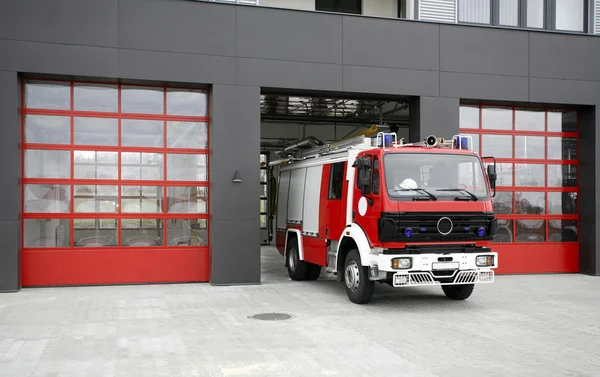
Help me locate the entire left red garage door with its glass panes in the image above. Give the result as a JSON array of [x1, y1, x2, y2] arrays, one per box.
[[21, 80, 209, 286]]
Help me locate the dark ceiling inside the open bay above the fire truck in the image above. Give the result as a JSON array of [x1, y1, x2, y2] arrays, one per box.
[[260, 94, 408, 127]]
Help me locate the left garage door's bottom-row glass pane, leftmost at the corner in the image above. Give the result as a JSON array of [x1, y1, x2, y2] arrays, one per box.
[[23, 219, 71, 247]]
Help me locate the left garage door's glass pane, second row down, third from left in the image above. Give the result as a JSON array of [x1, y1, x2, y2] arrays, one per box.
[[121, 119, 165, 147]]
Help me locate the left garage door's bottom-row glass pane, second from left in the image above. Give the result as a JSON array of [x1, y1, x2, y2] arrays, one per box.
[[73, 219, 117, 247]]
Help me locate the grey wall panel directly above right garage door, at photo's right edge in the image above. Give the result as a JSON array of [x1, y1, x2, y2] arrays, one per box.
[[529, 78, 600, 105]]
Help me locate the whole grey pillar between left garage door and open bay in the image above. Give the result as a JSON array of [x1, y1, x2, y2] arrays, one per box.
[[210, 85, 260, 284]]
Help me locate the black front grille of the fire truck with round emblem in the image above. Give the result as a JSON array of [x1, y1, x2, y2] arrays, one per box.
[[379, 212, 496, 242]]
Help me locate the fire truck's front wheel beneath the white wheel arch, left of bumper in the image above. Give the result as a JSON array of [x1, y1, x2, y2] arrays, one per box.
[[344, 249, 375, 304]]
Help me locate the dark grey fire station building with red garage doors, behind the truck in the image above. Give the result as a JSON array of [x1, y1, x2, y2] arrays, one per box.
[[0, 0, 600, 292]]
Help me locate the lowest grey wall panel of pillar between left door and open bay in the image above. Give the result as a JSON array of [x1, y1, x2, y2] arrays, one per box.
[[210, 217, 260, 285]]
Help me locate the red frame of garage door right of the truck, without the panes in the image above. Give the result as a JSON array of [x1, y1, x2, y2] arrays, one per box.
[[460, 103, 580, 273]]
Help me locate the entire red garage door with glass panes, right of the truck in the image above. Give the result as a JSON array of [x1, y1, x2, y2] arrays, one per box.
[[460, 105, 579, 273]]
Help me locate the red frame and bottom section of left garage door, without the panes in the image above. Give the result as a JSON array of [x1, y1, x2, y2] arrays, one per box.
[[20, 79, 210, 286]]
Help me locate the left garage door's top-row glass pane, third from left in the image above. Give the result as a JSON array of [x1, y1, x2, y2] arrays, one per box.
[[121, 85, 164, 114]]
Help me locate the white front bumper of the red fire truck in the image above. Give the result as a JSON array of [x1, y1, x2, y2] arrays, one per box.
[[370, 248, 498, 287]]
